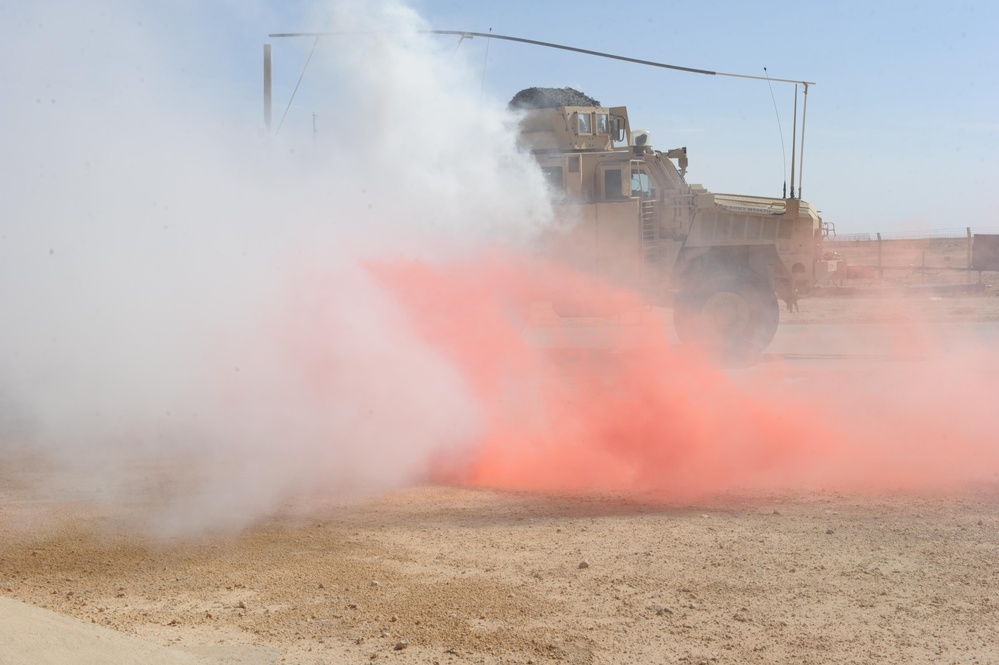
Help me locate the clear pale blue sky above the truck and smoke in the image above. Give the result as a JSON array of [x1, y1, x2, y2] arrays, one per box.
[[4, 0, 999, 233]]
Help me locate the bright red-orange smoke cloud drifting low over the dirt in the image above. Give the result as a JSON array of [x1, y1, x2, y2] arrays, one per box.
[[368, 252, 999, 502]]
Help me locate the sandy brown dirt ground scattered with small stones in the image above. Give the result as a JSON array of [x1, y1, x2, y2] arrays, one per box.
[[0, 252, 999, 664]]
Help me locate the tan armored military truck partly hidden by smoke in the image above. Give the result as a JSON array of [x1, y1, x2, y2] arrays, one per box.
[[510, 88, 823, 357]]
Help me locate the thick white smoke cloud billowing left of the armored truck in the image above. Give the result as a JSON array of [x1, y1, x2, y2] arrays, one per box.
[[0, 1, 549, 532]]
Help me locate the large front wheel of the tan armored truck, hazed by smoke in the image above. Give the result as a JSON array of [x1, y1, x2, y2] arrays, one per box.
[[673, 276, 780, 361]]
